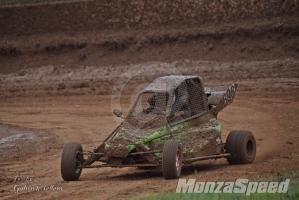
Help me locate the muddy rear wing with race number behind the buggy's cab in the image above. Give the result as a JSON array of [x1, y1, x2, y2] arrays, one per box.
[[205, 83, 237, 114]]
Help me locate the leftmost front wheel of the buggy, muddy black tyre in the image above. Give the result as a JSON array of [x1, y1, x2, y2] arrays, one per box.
[[61, 142, 84, 181]]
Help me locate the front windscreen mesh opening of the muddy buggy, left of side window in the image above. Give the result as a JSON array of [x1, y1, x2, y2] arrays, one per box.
[[132, 92, 169, 115]]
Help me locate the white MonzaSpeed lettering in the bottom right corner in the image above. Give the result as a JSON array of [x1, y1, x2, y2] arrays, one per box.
[[176, 178, 290, 195]]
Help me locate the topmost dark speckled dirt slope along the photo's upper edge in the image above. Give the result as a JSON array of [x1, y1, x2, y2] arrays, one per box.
[[0, 0, 298, 35]]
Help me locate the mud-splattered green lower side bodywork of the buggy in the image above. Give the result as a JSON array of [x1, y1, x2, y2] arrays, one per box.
[[106, 111, 221, 158]]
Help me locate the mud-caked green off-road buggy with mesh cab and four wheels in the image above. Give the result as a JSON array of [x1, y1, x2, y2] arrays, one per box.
[[61, 76, 256, 181]]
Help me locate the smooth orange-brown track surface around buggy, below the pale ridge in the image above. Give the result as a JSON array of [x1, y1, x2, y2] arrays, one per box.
[[0, 60, 299, 199]]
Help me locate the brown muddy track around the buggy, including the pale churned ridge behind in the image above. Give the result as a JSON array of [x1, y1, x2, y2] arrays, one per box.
[[0, 56, 299, 199]]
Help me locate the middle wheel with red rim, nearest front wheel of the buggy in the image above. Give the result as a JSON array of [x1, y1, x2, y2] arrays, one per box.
[[162, 140, 183, 179]]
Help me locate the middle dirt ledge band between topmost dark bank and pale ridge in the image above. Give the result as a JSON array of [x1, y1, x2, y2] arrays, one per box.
[[0, 17, 299, 74]]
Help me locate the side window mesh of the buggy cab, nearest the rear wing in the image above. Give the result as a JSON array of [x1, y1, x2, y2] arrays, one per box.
[[169, 79, 208, 122]]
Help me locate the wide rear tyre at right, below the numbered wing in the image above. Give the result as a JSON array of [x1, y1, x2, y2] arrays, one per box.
[[225, 130, 256, 164]]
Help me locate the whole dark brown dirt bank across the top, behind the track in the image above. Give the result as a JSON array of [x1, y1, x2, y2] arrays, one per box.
[[0, 0, 299, 73]]
